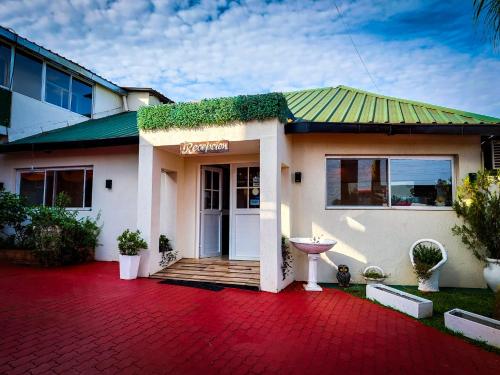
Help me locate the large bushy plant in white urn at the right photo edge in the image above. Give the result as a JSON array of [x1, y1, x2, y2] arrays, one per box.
[[452, 170, 500, 291]]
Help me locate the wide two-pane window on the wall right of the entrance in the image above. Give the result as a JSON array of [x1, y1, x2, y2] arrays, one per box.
[[326, 157, 453, 207]]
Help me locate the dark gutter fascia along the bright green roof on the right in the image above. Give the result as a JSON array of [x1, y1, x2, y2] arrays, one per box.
[[285, 122, 500, 136]]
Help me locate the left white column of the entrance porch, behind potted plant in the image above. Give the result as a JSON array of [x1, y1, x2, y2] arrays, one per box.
[[137, 144, 161, 277]]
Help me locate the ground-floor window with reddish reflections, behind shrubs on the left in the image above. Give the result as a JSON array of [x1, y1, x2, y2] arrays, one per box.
[[19, 168, 93, 208]]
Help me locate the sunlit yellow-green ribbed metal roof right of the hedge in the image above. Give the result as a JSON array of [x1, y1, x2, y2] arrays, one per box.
[[284, 86, 500, 125]]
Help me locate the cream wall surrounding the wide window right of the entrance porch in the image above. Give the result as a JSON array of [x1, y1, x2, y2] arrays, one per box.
[[290, 134, 484, 287]]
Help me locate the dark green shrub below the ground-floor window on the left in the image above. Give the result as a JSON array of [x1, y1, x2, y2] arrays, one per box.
[[29, 193, 101, 266]]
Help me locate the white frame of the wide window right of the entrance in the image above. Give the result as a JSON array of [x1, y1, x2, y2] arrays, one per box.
[[323, 155, 456, 211]]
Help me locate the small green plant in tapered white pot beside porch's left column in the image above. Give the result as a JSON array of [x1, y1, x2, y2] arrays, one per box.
[[117, 229, 148, 280]]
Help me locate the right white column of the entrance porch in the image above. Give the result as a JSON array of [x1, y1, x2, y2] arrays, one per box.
[[260, 133, 281, 293]]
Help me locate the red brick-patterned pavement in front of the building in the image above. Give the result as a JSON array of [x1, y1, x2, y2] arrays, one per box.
[[0, 262, 500, 375]]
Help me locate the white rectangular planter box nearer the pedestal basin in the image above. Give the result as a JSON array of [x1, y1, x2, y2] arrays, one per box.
[[366, 284, 432, 319]]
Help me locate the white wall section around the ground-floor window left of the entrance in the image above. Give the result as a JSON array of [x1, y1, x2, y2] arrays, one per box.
[[0, 146, 138, 260]]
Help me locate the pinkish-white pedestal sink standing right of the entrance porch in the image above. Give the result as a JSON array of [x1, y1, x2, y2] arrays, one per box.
[[290, 237, 337, 292]]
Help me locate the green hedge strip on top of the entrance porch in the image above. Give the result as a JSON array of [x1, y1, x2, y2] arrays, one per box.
[[137, 93, 290, 130]]
